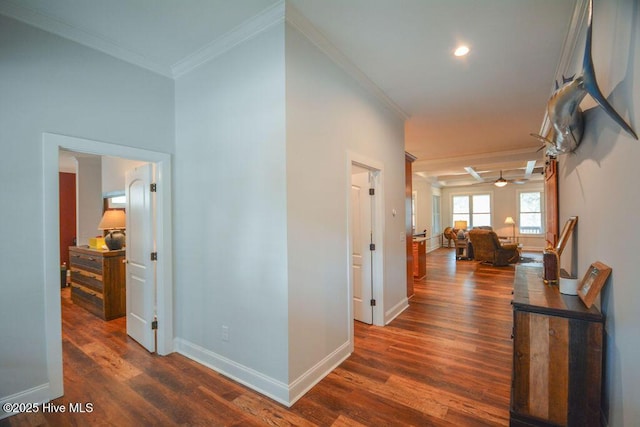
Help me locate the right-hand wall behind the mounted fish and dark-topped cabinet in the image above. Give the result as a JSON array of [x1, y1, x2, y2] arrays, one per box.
[[559, 0, 640, 426]]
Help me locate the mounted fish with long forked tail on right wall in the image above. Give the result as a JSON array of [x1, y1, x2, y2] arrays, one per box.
[[531, 0, 638, 157]]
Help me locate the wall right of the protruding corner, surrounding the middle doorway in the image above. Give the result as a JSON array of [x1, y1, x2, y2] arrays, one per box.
[[286, 25, 406, 388]]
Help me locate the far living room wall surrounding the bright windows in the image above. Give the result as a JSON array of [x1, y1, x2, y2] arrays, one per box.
[[442, 181, 545, 251]]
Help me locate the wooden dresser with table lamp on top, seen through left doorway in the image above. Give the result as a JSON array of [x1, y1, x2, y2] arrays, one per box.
[[69, 246, 126, 320]]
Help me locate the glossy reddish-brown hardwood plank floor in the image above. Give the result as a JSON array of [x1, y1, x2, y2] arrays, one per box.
[[0, 248, 514, 426]]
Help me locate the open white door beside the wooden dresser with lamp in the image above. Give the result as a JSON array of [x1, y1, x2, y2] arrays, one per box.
[[125, 164, 156, 352]]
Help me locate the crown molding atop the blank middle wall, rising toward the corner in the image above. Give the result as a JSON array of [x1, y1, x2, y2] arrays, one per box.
[[171, 1, 285, 78]]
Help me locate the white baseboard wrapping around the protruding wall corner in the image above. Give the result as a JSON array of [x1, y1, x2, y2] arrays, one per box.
[[174, 338, 351, 407]]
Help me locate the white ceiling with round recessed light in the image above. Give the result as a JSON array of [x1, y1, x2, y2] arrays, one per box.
[[0, 0, 575, 185]]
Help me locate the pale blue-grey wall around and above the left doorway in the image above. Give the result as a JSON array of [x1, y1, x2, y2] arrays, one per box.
[[0, 16, 174, 408]]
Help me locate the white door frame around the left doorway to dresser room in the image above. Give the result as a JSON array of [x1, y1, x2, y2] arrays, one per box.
[[42, 132, 174, 399]]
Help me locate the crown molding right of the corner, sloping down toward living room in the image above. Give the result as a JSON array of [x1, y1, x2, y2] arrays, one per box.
[[285, 3, 409, 121]]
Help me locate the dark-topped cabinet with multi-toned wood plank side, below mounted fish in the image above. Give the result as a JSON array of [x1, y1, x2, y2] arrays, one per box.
[[510, 265, 604, 427]]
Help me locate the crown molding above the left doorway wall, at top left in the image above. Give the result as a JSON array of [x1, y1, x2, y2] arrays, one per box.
[[0, 0, 172, 77]]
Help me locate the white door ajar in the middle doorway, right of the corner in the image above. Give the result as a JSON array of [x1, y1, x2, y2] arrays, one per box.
[[351, 166, 373, 324]]
